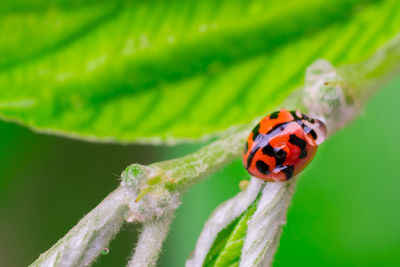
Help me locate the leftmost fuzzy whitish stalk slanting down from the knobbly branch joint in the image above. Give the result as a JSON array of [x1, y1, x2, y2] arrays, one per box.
[[31, 187, 133, 267]]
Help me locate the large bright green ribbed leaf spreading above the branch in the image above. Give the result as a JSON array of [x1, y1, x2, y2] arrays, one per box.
[[0, 0, 400, 142]]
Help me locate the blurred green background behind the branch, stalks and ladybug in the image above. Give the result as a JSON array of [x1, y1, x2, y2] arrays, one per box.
[[0, 77, 400, 267]]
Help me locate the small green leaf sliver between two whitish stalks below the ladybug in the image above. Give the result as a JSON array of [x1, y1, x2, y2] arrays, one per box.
[[203, 199, 259, 267]]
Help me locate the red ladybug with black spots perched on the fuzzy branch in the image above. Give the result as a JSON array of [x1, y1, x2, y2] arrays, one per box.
[[243, 109, 327, 182]]
